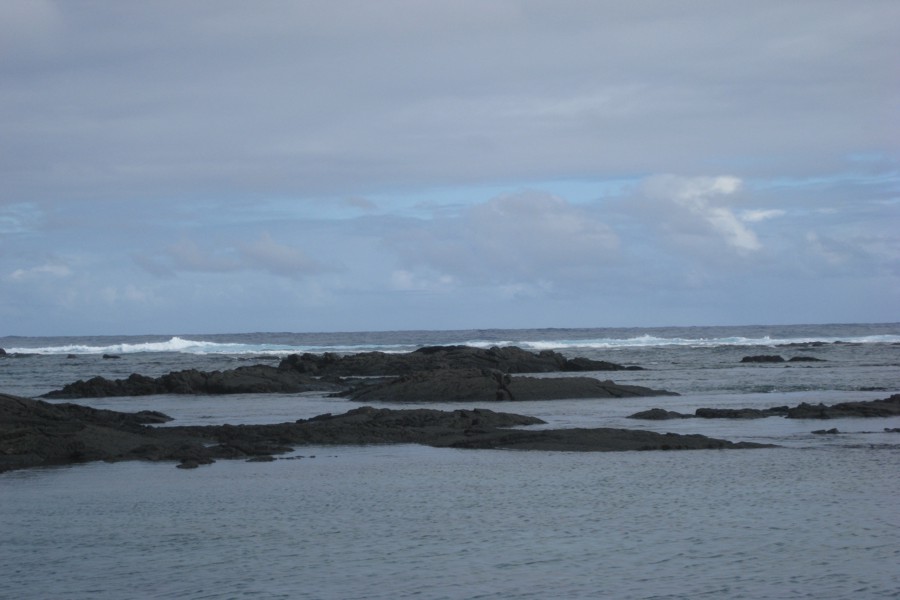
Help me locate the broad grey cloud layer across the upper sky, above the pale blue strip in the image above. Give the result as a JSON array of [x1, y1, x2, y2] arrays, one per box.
[[0, 1, 900, 201]]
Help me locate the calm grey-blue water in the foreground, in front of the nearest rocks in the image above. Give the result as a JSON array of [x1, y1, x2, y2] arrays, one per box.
[[0, 446, 900, 599]]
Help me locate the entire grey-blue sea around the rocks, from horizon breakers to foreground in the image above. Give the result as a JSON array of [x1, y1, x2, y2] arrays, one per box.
[[0, 323, 900, 599]]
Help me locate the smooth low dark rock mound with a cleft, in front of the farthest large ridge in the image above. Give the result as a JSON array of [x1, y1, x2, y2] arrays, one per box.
[[341, 369, 677, 402]]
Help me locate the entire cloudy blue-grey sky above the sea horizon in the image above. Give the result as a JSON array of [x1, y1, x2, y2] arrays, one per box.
[[0, 0, 900, 336]]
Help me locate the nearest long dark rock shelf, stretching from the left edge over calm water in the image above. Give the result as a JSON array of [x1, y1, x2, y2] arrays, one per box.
[[0, 394, 762, 472]]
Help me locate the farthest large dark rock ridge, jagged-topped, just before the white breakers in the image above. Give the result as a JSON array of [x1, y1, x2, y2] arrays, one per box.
[[279, 346, 640, 377]]
